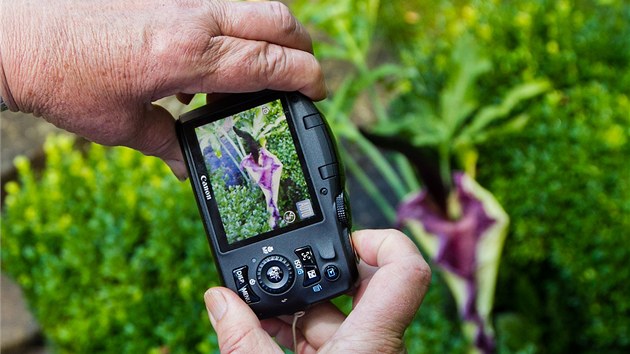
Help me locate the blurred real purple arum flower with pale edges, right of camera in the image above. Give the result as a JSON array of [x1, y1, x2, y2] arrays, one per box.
[[398, 172, 508, 353]]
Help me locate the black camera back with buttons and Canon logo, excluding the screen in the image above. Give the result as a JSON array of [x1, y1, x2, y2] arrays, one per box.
[[178, 91, 357, 318]]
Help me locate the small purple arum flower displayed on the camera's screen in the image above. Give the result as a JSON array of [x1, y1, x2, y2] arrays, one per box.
[[241, 147, 282, 229]]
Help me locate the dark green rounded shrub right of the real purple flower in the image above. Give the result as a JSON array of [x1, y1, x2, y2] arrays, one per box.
[[479, 83, 630, 353]]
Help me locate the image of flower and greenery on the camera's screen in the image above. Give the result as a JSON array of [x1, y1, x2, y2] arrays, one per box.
[[195, 100, 315, 244]]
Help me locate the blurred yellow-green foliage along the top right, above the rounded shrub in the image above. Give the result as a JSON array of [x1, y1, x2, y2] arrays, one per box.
[[379, 0, 630, 102]]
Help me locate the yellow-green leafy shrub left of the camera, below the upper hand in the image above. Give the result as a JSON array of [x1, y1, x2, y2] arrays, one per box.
[[2, 137, 218, 353]]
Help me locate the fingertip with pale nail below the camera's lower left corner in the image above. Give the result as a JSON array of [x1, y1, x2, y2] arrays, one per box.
[[204, 287, 283, 353]]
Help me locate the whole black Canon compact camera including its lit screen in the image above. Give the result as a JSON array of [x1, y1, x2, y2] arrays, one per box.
[[176, 91, 358, 319]]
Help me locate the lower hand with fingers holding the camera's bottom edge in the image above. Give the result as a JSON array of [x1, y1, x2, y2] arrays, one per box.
[[204, 230, 431, 353]]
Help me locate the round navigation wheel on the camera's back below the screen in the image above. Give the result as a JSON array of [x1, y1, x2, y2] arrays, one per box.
[[256, 255, 295, 294]]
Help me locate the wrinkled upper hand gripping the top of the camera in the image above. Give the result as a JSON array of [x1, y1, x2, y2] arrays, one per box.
[[0, 0, 325, 178]]
